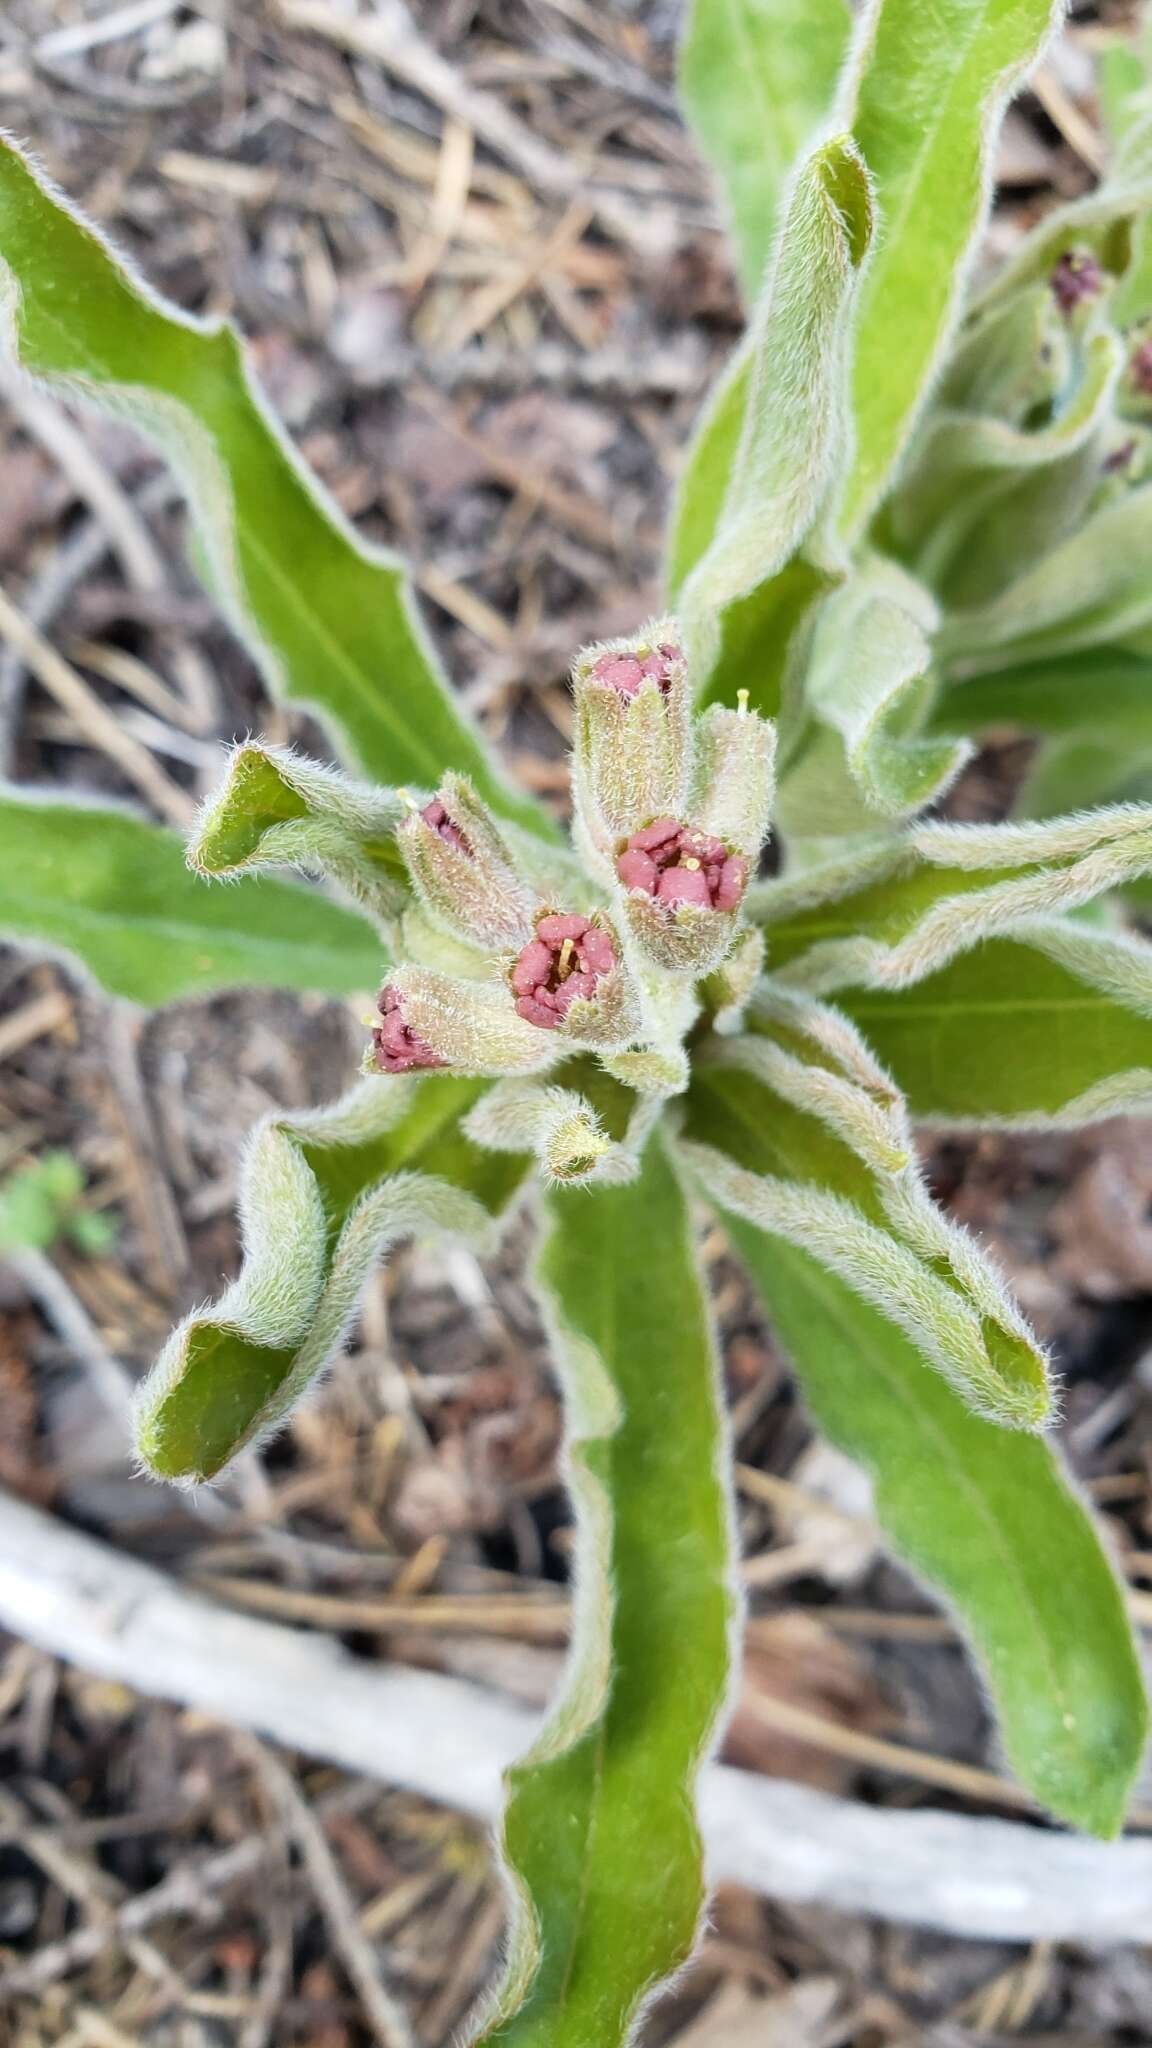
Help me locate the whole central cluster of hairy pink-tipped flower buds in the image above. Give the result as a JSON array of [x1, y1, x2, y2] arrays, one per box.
[[369, 623, 773, 1092]]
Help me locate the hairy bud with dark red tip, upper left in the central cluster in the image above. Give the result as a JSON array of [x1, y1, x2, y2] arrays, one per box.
[[400, 774, 533, 952]]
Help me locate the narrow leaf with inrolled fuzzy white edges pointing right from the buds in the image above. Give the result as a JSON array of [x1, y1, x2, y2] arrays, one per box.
[[750, 803, 1152, 995]]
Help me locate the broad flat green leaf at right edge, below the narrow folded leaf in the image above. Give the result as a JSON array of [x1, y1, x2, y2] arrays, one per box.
[[836, 926, 1152, 1128]]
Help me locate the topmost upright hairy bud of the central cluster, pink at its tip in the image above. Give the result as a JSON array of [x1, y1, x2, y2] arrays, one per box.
[[572, 621, 691, 862]]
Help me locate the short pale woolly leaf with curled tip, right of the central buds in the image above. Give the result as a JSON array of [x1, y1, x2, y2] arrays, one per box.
[[777, 563, 970, 836]]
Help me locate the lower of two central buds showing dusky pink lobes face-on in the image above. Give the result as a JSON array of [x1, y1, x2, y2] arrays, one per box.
[[508, 911, 640, 1047]]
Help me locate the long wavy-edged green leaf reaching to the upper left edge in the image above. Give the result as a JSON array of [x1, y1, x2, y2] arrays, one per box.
[[0, 135, 547, 829]]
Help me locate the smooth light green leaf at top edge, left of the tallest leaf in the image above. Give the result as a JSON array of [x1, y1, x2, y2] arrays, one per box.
[[681, 0, 851, 301]]
